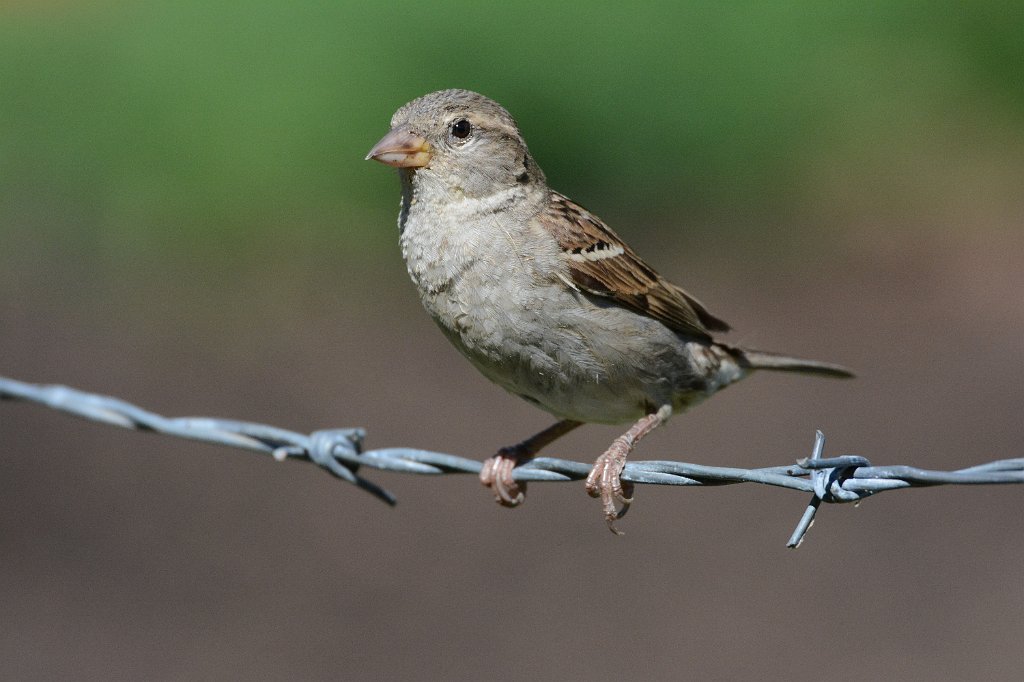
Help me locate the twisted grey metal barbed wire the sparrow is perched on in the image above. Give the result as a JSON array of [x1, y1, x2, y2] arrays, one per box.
[[0, 377, 1024, 548]]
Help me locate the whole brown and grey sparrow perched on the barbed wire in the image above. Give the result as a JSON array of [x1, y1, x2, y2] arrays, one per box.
[[367, 90, 852, 534]]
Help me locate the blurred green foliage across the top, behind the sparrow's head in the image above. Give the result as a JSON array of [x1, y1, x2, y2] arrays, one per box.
[[0, 0, 1024, 260]]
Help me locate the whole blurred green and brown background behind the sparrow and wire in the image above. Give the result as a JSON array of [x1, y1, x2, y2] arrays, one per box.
[[0, 0, 1024, 680]]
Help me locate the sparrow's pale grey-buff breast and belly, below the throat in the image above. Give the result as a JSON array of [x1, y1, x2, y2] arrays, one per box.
[[400, 183, 745, 423]]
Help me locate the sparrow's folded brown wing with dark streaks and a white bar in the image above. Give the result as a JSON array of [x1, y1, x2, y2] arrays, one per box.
[[538, 191, 729, 340]]
